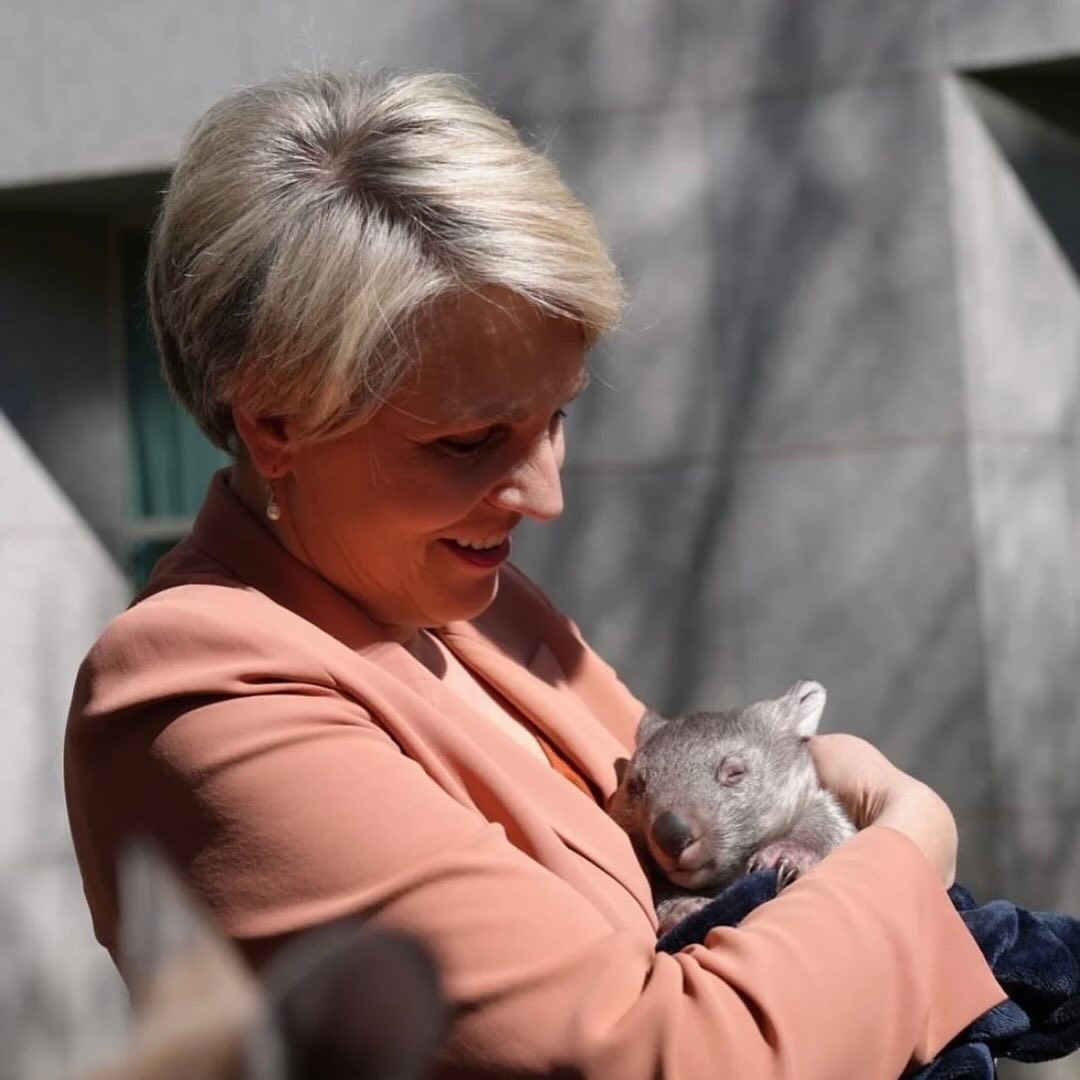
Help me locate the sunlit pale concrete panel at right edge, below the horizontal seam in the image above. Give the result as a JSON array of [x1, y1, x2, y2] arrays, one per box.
[[970, 444, 1080, 908]]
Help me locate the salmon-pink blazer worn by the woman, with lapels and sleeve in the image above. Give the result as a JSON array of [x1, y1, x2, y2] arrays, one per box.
[[65, 474, 1002, 1080]]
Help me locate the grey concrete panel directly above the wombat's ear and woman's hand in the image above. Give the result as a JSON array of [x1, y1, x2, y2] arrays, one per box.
[[733, 446, 994, 864]]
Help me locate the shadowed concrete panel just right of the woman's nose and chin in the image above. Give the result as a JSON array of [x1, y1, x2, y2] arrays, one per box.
[[514, 464, 744, 711]]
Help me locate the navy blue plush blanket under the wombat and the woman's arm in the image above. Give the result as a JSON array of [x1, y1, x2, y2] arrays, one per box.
[[657, 870, 1080, 1080]]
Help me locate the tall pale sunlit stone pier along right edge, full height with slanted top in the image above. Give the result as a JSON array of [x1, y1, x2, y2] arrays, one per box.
[[944, 69, 1080, 909]]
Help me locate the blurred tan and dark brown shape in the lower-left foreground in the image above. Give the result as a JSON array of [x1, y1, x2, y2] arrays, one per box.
[[78, 840, 449, 1080]]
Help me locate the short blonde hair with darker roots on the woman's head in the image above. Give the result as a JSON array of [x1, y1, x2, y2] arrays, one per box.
[[148, 72, 623, 450]]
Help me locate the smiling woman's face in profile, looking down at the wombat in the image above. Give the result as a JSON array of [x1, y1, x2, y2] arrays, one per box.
[[274, 289, 585, 639]]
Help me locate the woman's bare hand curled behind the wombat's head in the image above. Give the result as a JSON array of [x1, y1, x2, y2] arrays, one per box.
[[810, 734, 959, 888]]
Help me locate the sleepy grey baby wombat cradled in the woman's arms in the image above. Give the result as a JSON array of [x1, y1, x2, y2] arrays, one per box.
[[608, 681, 855, 933]]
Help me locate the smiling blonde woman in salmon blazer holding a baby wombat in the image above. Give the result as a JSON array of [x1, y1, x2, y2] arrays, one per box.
[[66, 76, 1002, 1080]]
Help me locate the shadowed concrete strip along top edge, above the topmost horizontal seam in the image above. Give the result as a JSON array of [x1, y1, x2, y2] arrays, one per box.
[[464, 0, 940, 116]]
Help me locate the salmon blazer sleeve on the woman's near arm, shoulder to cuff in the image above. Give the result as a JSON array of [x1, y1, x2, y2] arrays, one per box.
[[67, 600, 1002, 1080]]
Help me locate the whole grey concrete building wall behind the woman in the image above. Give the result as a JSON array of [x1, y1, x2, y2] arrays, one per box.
[[0, 0, 1080, 1077]]
